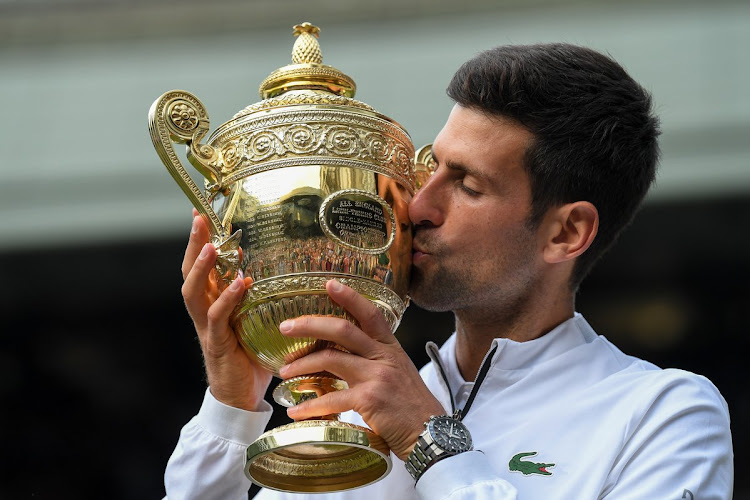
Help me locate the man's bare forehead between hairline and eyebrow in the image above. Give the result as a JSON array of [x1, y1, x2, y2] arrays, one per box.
[[432, 104, 534, 182]]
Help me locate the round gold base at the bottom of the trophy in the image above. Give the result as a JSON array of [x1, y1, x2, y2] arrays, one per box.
[[245, 420, 392, 493]]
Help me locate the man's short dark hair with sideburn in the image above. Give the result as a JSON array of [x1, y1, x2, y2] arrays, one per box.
[[447, 43, 659, 289]]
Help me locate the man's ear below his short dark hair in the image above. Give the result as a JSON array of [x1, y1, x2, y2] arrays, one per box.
[[544, 201, 599, 264]]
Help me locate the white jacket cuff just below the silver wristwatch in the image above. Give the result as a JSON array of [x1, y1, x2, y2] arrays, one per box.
[[417, 451, 516, 500]]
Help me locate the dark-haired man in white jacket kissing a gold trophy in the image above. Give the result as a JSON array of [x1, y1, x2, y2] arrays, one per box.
[[166, 44, 733, 500]]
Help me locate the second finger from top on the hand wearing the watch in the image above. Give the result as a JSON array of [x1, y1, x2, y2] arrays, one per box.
[[279, 316, 378, 359]]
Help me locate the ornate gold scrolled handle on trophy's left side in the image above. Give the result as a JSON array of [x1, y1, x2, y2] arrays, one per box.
[[148, 90, 242, 284]]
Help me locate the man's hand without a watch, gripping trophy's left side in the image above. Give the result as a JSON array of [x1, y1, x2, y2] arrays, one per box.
[[182, 211, 271, 411]]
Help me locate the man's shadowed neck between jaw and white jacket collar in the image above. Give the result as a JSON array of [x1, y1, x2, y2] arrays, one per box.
[[454, 292, 575, 380]]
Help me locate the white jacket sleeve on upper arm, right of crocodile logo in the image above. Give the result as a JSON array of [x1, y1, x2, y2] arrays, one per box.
[[600, 370, 734, 500]]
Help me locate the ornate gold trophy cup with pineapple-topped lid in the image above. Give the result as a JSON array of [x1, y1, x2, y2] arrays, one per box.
[[149, 23, 429, 492]]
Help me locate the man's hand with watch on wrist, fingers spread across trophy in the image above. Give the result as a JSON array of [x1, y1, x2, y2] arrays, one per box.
[[280, 280, 445, 460]]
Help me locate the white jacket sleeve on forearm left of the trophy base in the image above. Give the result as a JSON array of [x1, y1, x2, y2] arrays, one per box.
[[164, 390, 272, 500]]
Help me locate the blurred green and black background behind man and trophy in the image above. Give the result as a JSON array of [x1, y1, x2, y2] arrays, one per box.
[[0, 0, 750, 499]]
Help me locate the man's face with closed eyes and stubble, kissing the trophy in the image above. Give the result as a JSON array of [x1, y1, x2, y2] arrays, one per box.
[[409, 105, 541, 316]]
